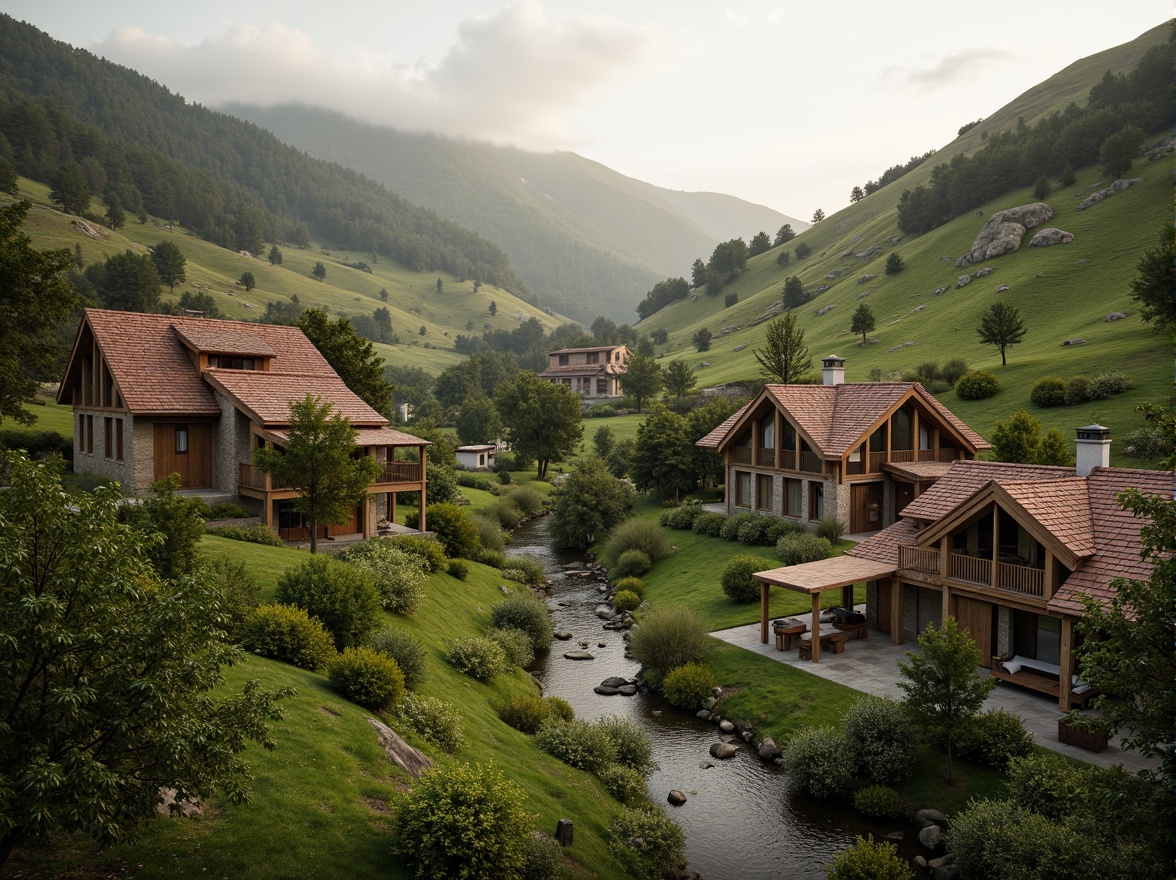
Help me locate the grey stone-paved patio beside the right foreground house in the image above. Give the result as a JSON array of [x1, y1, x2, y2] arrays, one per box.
[[711, 624, 1158, 773]]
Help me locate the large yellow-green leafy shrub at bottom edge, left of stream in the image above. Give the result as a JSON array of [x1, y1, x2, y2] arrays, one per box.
[[392, 764, 530, 880]]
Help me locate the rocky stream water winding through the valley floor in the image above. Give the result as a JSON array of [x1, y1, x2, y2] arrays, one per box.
[[510, 518, 912, 880]]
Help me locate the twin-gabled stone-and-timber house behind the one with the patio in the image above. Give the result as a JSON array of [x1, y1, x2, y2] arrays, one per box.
[[697, 355, 991, 533]]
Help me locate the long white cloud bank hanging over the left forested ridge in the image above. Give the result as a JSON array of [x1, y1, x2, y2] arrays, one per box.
[[93, 0, 661, 148]]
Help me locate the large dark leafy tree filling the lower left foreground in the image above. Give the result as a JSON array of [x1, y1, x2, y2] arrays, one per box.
[[0, 455, 286, 868]]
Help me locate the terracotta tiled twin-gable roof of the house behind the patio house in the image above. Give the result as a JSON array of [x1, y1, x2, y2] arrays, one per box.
[[697, 382, 991, 459]]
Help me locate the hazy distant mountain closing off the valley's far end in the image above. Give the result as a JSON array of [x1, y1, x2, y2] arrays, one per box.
[[226, 105, 807, 324]]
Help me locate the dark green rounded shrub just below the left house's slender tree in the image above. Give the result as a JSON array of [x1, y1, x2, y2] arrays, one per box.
[[276, 556, 380, 651]]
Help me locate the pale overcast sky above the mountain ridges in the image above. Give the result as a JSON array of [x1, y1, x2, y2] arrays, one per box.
[[0, 0, 1172, 220]]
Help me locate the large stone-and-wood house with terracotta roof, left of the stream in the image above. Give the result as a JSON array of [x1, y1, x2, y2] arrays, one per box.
[[58, 308, 428, 540]]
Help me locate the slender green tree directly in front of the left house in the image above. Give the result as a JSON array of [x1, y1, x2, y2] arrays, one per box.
[[253, 394, 380, 553]]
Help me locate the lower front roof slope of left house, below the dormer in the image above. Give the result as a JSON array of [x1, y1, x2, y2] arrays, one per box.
[[205, 369, 388, 427]]
